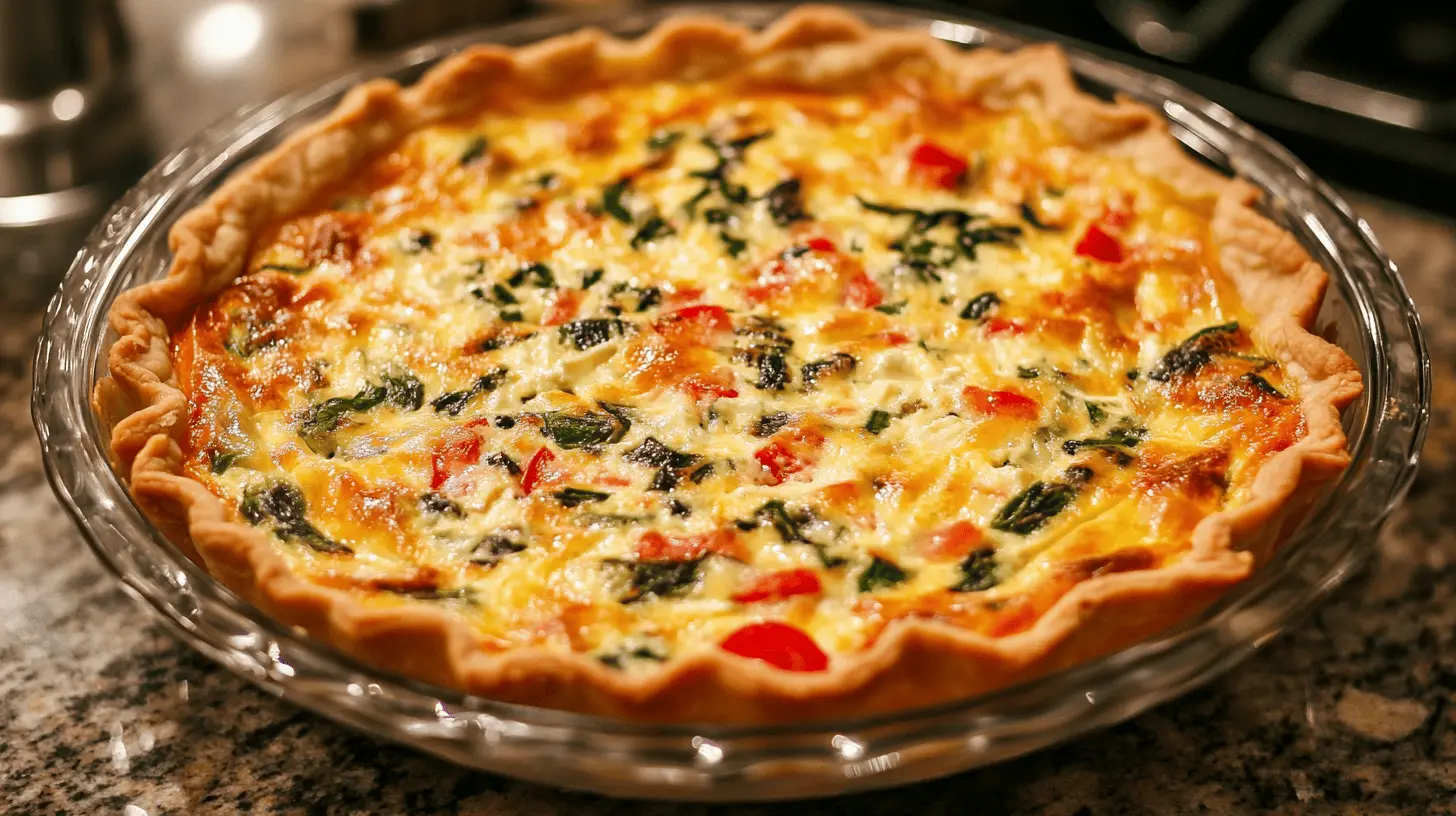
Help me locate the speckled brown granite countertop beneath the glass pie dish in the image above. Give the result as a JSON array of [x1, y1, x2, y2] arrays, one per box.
[[0, 0, 1456, 816]]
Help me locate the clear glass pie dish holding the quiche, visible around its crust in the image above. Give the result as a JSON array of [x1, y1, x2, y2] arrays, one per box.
[[33, 6, 1430, 800]]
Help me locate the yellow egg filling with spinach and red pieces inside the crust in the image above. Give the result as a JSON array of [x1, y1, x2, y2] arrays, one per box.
[[173, 71, 1305, 672]]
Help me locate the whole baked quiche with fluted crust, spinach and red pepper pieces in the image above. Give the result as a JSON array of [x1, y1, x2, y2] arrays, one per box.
[[95, 7, 1360, 723]]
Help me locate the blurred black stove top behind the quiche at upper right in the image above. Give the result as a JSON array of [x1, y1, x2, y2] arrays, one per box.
[[913, 0, 1456, 214]]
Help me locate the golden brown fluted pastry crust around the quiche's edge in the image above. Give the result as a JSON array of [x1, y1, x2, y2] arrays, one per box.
[[93, 7, 1361, 723]]
